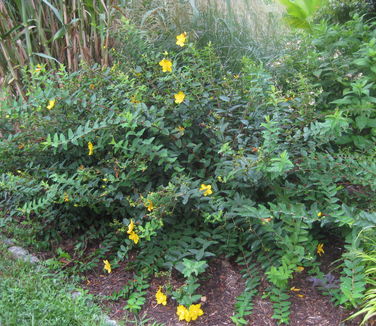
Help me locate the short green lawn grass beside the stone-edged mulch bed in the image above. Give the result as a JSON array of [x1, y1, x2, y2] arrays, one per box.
[[0, 245, 105, 326]]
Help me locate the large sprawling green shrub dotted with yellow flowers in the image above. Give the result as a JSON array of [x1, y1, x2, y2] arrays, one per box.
[[0, 18, 376, 323]]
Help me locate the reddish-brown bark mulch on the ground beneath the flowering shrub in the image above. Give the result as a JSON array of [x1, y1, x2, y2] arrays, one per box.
[[80, 248, 368, 326]]
